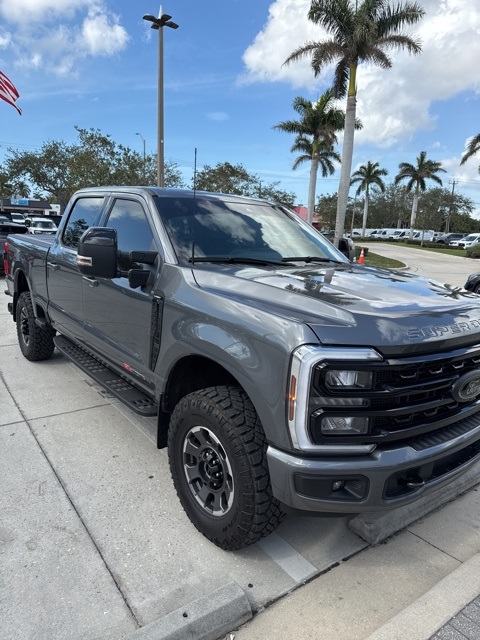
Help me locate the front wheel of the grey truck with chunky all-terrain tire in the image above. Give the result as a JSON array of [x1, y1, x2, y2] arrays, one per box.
[[168, 387, 283, 551]]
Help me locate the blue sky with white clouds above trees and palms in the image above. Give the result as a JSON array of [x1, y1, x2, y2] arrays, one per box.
[[0, 0, 480, 217]]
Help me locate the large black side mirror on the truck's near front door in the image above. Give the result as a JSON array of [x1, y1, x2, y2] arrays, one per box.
[[77, 227, 117, 278]]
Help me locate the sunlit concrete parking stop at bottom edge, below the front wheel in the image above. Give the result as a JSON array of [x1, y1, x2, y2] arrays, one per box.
[[123, 582, 253, 640]]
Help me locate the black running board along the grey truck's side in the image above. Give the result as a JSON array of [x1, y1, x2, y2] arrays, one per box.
[[53, 335, 158, 416]]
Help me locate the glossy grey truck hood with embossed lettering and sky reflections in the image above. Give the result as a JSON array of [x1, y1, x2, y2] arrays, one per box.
[[194, 264, 480, 355]]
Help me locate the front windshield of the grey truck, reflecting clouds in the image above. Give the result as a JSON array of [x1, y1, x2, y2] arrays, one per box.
[[156, 196, 347, 264]]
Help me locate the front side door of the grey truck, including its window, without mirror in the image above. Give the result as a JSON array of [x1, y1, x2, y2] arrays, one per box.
[[83, 195, 162, 387]]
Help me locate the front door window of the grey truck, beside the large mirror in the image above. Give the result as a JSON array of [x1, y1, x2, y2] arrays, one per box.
[[107, 198, 157, 271]]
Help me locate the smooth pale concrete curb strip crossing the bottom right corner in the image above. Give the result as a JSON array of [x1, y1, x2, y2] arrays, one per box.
[[366, 553, 480, 640]]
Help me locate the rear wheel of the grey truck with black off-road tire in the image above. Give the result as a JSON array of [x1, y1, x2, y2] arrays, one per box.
[[16, 291, 55, 362]]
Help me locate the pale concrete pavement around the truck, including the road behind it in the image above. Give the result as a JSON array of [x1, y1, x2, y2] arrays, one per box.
[[0, 245, 480, 640]]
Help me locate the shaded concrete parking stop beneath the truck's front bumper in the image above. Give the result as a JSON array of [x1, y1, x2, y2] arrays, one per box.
[[348, 463, 480, 544]]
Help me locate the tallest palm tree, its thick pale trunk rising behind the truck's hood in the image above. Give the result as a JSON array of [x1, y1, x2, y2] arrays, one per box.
[[285, 0, 425, 246]]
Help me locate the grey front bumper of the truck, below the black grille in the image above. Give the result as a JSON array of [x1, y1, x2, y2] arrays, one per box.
[[267, 415, 480, 514]]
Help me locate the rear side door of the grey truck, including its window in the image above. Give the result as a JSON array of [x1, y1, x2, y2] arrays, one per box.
[[47, 196, 105, 340]]
